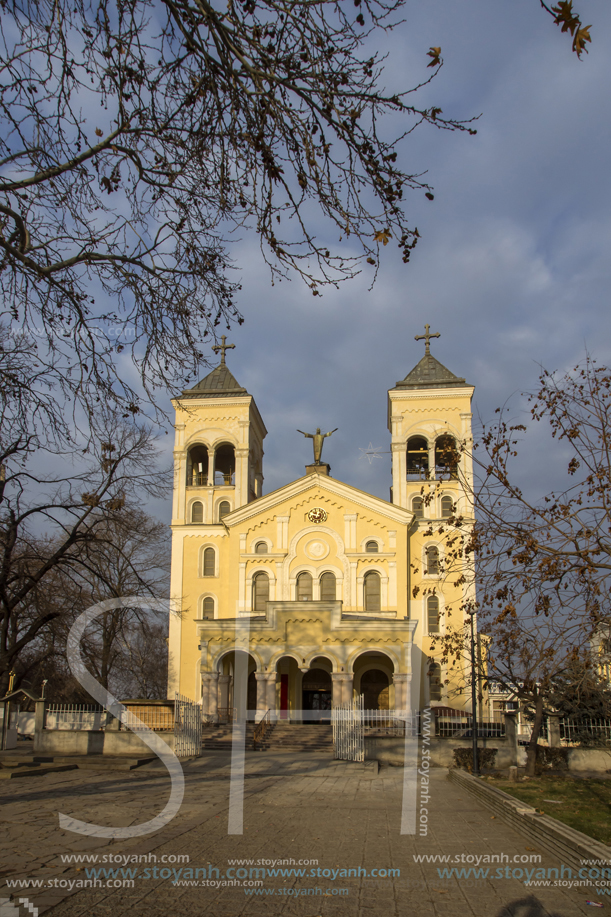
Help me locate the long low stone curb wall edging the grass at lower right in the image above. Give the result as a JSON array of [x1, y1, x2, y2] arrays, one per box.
[[449, 768, 611, 878]]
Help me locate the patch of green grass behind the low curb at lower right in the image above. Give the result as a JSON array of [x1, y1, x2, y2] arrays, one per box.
[[490, 776, 611, 846]]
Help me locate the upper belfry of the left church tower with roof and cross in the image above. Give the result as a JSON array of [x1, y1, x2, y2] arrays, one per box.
[[172, 335, 267, 525]]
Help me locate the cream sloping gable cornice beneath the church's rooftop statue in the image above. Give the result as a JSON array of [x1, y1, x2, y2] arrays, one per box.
[[223, 474, 414, 528]]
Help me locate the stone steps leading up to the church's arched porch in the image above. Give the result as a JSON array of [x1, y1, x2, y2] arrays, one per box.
[[202, 720, 333, 756]]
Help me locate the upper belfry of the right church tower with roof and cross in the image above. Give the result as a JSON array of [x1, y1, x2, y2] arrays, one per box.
[[388, 325, 474, 522]]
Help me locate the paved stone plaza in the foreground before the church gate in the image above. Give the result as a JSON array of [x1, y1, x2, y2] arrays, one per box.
[[0, 752, 611, 917]]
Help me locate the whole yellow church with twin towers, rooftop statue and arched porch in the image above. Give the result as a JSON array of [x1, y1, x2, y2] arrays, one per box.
[[168, 325, 473, 723]]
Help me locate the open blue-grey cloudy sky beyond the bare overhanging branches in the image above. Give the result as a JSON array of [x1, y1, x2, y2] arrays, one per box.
[[151, 0, 611, 516]]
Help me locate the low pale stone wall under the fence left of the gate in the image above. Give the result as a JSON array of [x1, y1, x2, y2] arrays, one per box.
[[34, 729, 174, 756]]
